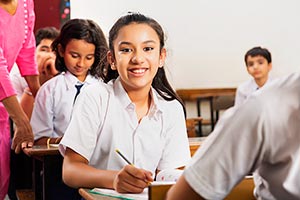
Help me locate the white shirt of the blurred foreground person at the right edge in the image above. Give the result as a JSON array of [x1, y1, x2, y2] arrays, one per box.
[[184, 74, 300, 200]]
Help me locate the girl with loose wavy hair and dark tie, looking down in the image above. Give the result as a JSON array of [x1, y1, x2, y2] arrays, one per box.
[[31, 19, 108, 145]]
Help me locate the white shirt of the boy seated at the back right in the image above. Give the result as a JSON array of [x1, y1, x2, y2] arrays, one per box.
[[234, 78, 272, 106]]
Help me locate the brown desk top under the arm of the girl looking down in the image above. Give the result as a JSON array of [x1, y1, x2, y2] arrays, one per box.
[[23, 145, 60, 156]]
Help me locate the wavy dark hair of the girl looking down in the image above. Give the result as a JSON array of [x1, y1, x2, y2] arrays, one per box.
[[51, 19, 108, 79]]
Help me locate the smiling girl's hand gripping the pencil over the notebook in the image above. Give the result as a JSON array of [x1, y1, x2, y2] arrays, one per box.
[[113, 165, 153, 193]]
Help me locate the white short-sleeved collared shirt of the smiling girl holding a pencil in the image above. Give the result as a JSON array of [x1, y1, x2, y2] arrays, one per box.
[[59, 78, 190, 175]]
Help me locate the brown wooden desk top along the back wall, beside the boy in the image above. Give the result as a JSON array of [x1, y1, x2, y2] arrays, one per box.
[[176, 88, 236, 101]]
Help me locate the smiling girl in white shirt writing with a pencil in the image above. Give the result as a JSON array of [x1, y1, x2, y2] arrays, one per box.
[[59, 13, 190, 193]]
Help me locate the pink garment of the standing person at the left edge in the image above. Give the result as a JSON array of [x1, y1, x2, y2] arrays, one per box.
[[0, 0, 38, 200]]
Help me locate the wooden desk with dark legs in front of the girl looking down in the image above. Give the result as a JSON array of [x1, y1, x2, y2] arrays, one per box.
[[23, 145, 62, 200]]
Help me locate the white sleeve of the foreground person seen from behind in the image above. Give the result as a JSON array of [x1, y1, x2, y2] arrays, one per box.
[[184, 101, 270, 199]]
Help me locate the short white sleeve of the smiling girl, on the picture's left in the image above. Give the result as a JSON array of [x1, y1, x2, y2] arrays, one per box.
[[59, 84, 107, 161]]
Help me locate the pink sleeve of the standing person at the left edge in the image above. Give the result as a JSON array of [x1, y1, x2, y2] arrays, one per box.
[[16, 0, 38, 76]]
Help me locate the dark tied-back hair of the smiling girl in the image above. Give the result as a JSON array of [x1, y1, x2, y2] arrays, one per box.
[[104, 13, 186, 114]]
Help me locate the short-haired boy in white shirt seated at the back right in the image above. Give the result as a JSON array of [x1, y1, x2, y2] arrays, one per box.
[[234, 47, 272, 105]]
